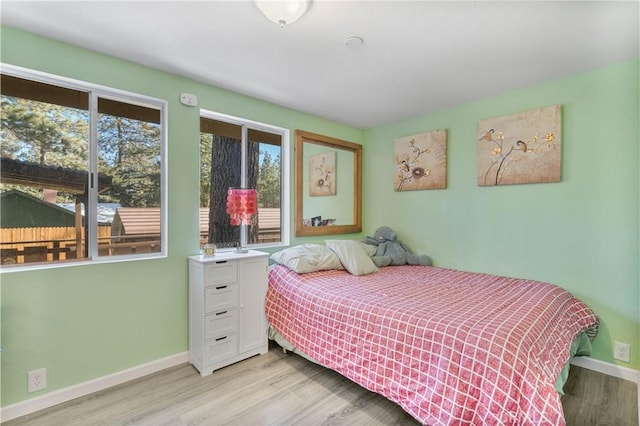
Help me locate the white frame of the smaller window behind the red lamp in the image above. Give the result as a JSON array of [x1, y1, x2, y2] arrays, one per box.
[[198, 108, 291, 251]]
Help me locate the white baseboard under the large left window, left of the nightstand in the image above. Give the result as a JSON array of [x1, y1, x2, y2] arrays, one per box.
[[0, 352, 189, 422]]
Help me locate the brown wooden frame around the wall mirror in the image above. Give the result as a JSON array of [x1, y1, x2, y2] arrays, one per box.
[[295, 130, 362, 237]]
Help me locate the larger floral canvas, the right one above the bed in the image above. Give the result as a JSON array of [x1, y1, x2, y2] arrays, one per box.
[[478, 105, 562, 186]]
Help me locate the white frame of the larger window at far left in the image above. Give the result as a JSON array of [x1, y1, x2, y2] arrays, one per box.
[[0, 62, 169, 274]]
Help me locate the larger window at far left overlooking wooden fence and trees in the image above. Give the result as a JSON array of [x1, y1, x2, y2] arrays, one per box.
[[0, 66, 166, 269]]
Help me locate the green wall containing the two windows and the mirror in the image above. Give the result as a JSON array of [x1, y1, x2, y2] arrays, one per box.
[[0, 27, 363, 406]]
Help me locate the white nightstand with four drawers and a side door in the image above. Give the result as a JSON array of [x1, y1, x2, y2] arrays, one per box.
[[189, 250, 269, 376]]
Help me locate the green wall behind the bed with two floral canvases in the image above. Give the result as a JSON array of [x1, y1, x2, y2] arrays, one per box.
[[363, 60, 640, 370]]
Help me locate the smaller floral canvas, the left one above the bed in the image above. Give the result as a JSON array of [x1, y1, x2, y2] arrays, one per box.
[[394, 130, 447, 191]]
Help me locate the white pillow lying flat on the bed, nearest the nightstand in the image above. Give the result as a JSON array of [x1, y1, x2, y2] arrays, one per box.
[[271, 244, 344, 274]]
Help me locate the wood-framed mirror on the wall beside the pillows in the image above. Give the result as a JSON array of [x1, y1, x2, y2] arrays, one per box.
[[295, 130, 362, 237]]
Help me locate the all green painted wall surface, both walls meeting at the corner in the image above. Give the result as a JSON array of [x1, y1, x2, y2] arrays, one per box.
[[0, 27, 640, 406]]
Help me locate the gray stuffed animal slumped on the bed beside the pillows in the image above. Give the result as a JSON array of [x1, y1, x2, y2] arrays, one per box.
[[362, 226, 431, 267]]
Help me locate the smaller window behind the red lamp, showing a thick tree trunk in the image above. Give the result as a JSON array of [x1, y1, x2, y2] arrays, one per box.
[[200, 111, 289, 248]]
